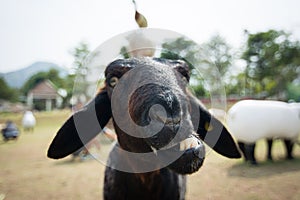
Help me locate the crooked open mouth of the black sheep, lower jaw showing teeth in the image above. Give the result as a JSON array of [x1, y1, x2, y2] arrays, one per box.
[[151, 136, 205, 174]]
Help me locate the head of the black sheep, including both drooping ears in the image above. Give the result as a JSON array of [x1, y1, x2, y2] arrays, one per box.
[[48, 58, 240, 174]]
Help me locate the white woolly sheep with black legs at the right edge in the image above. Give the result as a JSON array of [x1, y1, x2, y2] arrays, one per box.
[[227, 100, 300, 164]]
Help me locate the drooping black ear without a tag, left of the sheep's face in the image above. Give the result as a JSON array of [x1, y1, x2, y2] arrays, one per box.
[[47, 91, 111, 159]]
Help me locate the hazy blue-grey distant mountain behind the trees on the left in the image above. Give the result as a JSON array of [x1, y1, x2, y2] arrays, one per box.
[[0, 62, 68, 88]]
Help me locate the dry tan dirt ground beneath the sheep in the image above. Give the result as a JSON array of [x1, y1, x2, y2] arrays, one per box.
[[0, 111, 300, 200]]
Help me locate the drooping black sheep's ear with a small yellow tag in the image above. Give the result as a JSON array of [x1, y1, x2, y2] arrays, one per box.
[[190, 96, 241, 158]]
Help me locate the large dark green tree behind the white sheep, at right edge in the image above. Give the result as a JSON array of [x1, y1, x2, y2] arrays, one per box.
[[242, 30, 300, 98]]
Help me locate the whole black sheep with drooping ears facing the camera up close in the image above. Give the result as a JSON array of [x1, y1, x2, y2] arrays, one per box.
[[48, 58, 240, 200]]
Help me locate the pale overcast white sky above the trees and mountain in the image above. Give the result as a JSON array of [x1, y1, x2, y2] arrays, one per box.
[[0, 0, 300, 72]]
